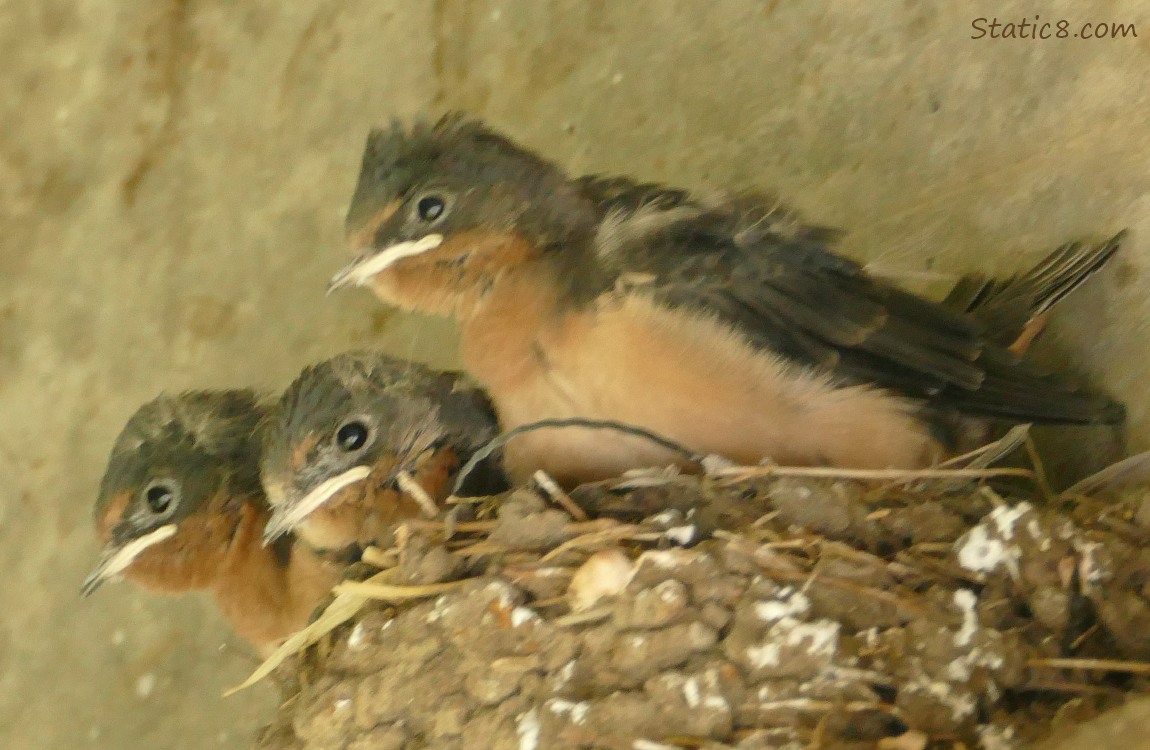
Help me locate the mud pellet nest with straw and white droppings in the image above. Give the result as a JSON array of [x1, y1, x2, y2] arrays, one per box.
[[249, 464, 1150, 750]]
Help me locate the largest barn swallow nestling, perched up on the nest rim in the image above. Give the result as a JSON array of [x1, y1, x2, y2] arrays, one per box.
[[331, 116, 1124, 483]]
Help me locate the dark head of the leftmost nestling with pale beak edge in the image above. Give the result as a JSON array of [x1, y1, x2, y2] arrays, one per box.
[[81, 390, 263, 596]]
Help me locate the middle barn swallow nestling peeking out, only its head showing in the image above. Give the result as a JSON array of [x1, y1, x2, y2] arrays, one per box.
[[261, 352, 501, 552]]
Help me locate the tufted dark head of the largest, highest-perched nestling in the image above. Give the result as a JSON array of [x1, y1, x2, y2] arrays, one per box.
[[330, 115, 596, 315]]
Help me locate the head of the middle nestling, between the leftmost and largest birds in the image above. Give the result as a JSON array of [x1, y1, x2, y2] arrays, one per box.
[[261, 352, 454, 549]]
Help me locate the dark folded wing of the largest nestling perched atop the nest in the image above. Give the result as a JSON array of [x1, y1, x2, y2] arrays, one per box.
[[595, 198, 1120, 422]]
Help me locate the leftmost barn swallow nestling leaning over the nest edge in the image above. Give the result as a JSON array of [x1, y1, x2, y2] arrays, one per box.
[[82, 390, 339, 653]]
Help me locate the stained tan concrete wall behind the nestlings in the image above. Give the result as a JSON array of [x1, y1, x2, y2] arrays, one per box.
[[0, 0, 1150, 748]]
